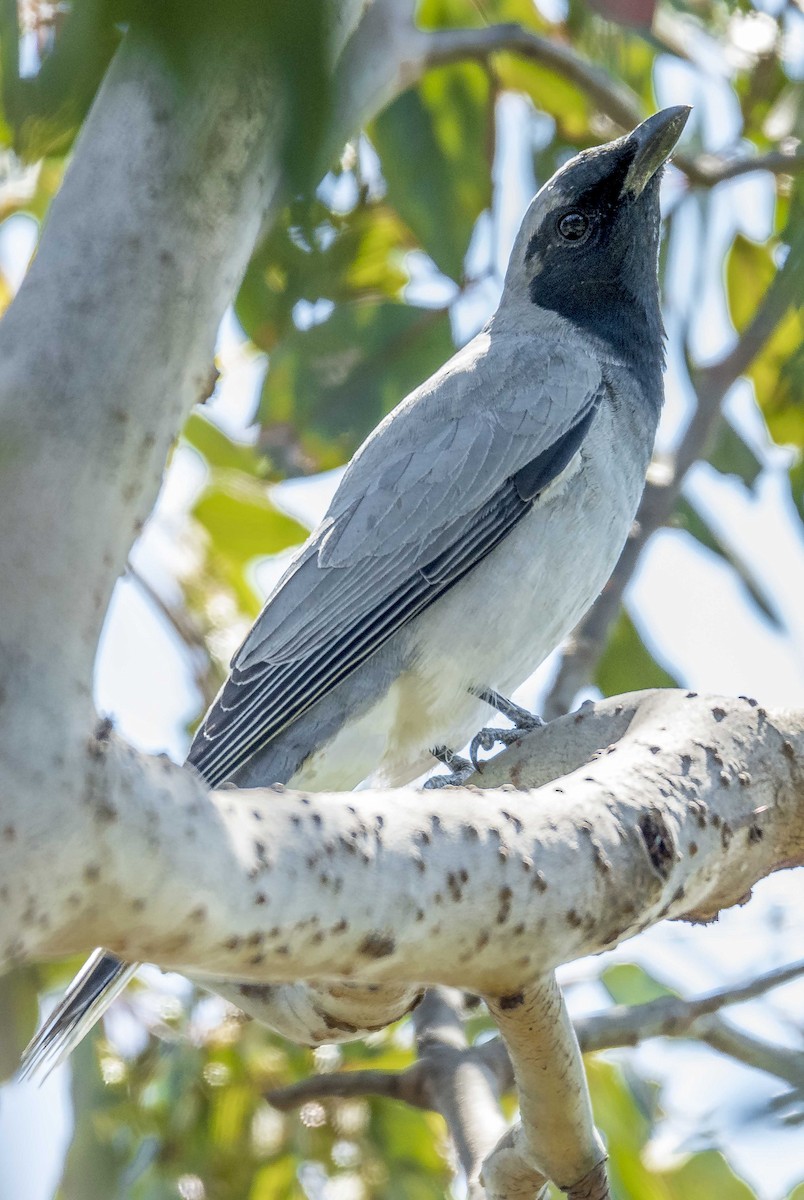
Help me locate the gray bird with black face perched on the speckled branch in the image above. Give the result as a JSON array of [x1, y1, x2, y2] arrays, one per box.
[[22, 106, 690, 1073]]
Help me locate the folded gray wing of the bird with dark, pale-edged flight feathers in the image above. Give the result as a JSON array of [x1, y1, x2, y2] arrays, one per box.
[[187, 334, 602, 786]]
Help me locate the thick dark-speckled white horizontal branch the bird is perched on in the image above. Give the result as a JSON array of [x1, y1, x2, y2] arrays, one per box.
[[0, 691, 804, 988]]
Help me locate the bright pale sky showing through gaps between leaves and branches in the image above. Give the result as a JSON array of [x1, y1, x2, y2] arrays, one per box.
[[0, 32, 804, 1200]]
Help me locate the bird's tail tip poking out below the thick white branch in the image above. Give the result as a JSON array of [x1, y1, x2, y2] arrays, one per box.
[[19, 949, 139, 1079]]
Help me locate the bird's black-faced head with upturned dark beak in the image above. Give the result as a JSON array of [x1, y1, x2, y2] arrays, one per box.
[[500, 106, 690, 379]]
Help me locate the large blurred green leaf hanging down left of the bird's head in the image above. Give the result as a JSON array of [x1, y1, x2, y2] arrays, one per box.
[[370, 62, 494, 281]]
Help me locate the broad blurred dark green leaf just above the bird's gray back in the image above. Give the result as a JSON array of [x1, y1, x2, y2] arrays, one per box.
[[259, 301, 452, 469]]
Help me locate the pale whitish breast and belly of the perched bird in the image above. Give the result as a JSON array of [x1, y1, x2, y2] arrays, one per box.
[[292, 396, 644, 787]]
